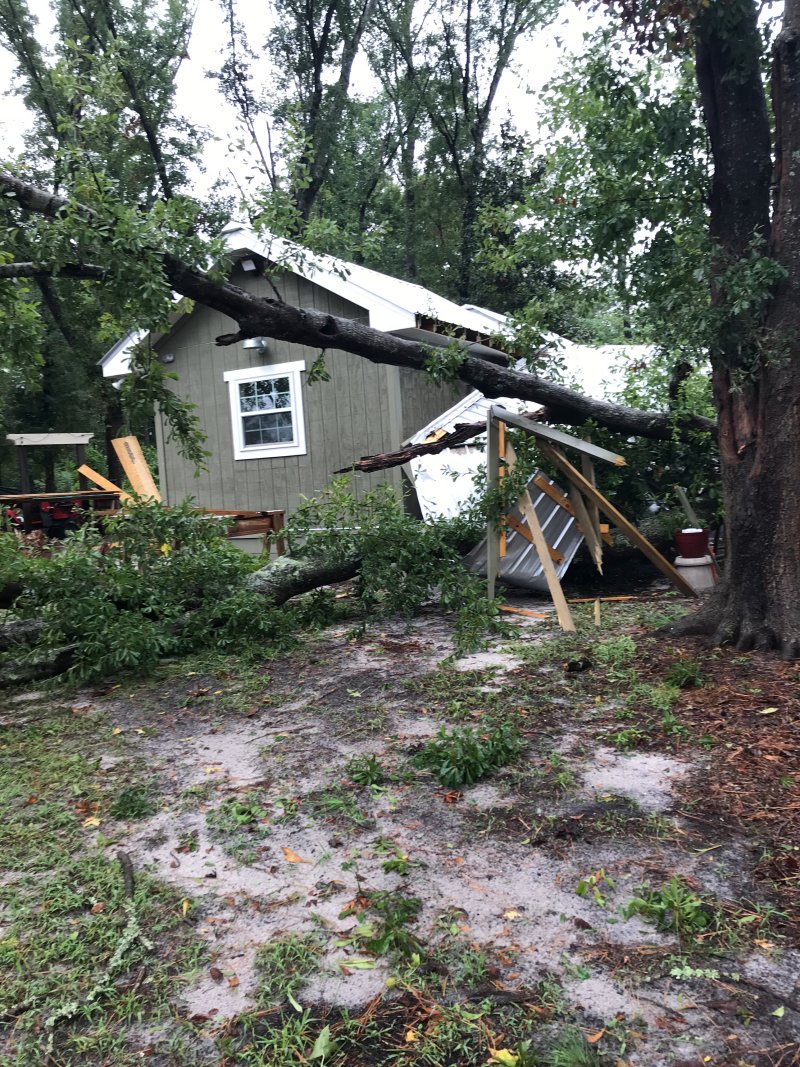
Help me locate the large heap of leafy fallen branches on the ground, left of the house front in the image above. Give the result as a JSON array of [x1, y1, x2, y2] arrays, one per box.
[[0, 503, 292, 681]]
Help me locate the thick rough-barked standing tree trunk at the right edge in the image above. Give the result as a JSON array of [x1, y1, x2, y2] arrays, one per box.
[[678, 0, 800, 658]]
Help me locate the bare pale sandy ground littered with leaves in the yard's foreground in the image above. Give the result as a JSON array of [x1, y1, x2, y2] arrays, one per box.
[[62, 616, 800, 1067]]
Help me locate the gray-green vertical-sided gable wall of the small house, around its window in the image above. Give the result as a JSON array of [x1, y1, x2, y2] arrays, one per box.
[[156, 268, 463, 512]]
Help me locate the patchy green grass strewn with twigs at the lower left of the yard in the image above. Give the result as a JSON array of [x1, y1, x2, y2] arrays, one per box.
[[0, 716, 198, 1067]]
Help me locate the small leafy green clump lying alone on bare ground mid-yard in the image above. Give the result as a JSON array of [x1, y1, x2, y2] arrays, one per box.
[[414, 723, 524, 789]]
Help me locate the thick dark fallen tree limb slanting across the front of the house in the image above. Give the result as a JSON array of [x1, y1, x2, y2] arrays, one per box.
[[0, 172, 715, 441]]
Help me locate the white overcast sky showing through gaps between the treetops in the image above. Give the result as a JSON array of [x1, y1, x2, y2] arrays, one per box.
[[0, 0, 596, 187]]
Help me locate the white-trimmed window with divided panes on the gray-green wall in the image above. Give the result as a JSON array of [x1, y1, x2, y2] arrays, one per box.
[[223, 361, 306, 460]]
